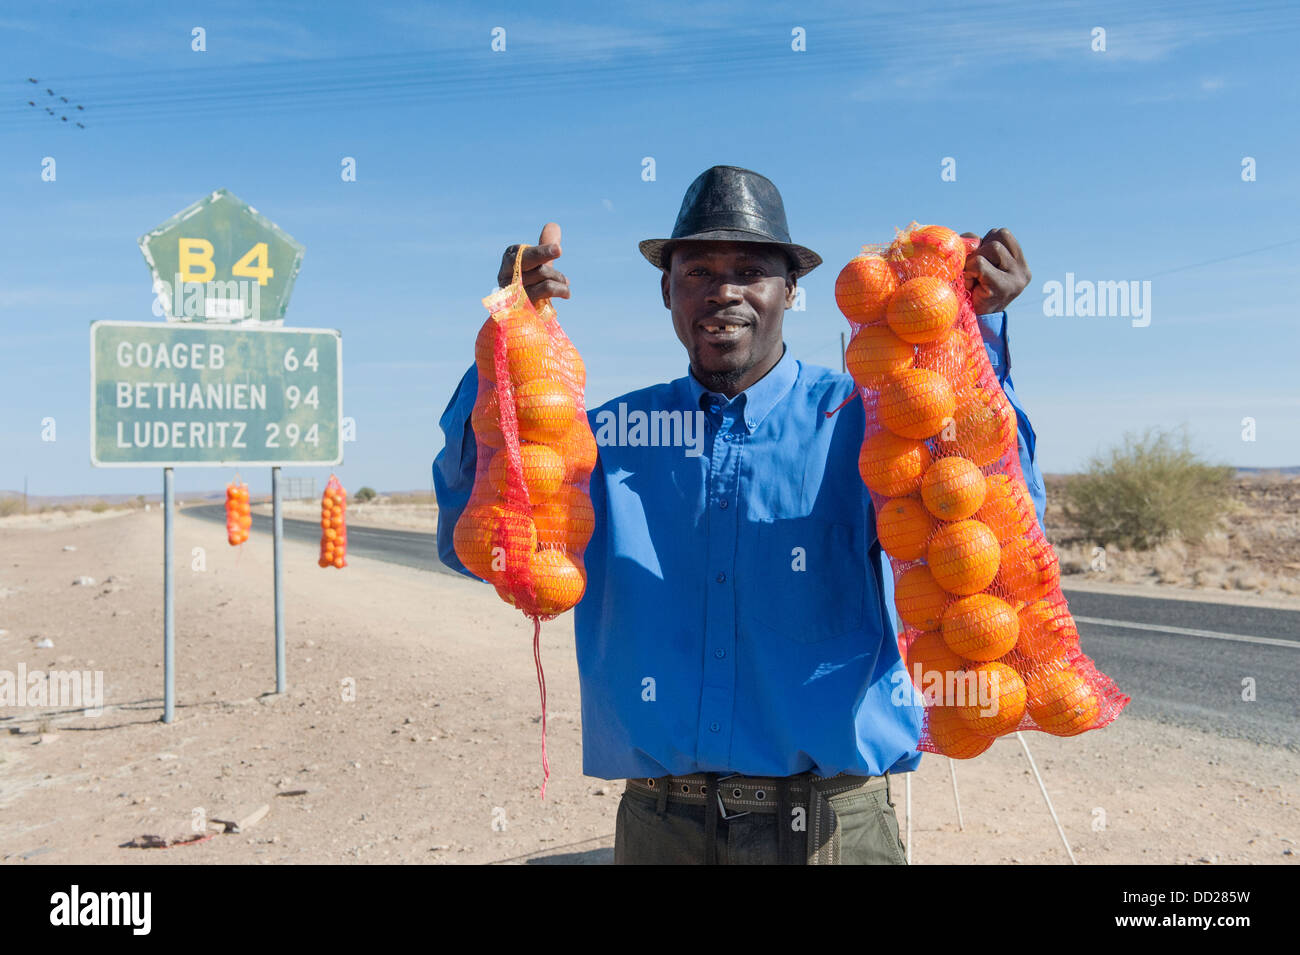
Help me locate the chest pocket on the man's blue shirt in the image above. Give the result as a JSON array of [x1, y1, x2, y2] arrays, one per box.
[[746, 517, 867, 643]]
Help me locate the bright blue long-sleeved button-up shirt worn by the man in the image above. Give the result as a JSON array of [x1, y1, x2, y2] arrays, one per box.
[[433, 313, 1045, 780]]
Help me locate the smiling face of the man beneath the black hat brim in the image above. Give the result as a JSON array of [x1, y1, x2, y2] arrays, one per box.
[[662, 242, 794, 398]]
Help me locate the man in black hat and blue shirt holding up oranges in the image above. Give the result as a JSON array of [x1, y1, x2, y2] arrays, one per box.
[[433, 166, 1044, 864]]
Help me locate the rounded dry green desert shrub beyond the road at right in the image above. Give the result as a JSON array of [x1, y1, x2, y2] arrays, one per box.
[[1062, 429, 1235, 550]]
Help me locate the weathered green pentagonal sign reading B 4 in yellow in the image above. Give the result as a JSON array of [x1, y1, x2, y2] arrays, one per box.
[[140, 188, 303, 325]]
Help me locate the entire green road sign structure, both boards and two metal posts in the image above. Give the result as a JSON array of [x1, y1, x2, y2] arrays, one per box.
[[90, 188, 327, 722]]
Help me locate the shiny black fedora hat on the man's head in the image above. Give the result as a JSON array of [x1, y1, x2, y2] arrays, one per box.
[[640, 166, 822, 277]]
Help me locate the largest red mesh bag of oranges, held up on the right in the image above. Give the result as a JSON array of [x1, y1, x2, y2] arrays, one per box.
[[835, 223, 1128, 759]]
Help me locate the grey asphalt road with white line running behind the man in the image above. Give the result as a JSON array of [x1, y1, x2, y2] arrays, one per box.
[[185, 504, 1300, 751]]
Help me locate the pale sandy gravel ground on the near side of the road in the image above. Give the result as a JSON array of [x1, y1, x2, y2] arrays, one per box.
[[0, 509, 1300, 864]]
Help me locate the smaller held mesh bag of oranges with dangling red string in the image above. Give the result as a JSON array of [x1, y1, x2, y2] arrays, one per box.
[[452, 246, 597, 795]]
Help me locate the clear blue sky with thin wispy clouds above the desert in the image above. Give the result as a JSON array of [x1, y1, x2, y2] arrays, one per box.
[[0, 3, 1300, 494]]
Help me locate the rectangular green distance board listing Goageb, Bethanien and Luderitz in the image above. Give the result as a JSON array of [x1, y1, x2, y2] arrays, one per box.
[[90, 322, 343, 468]]
